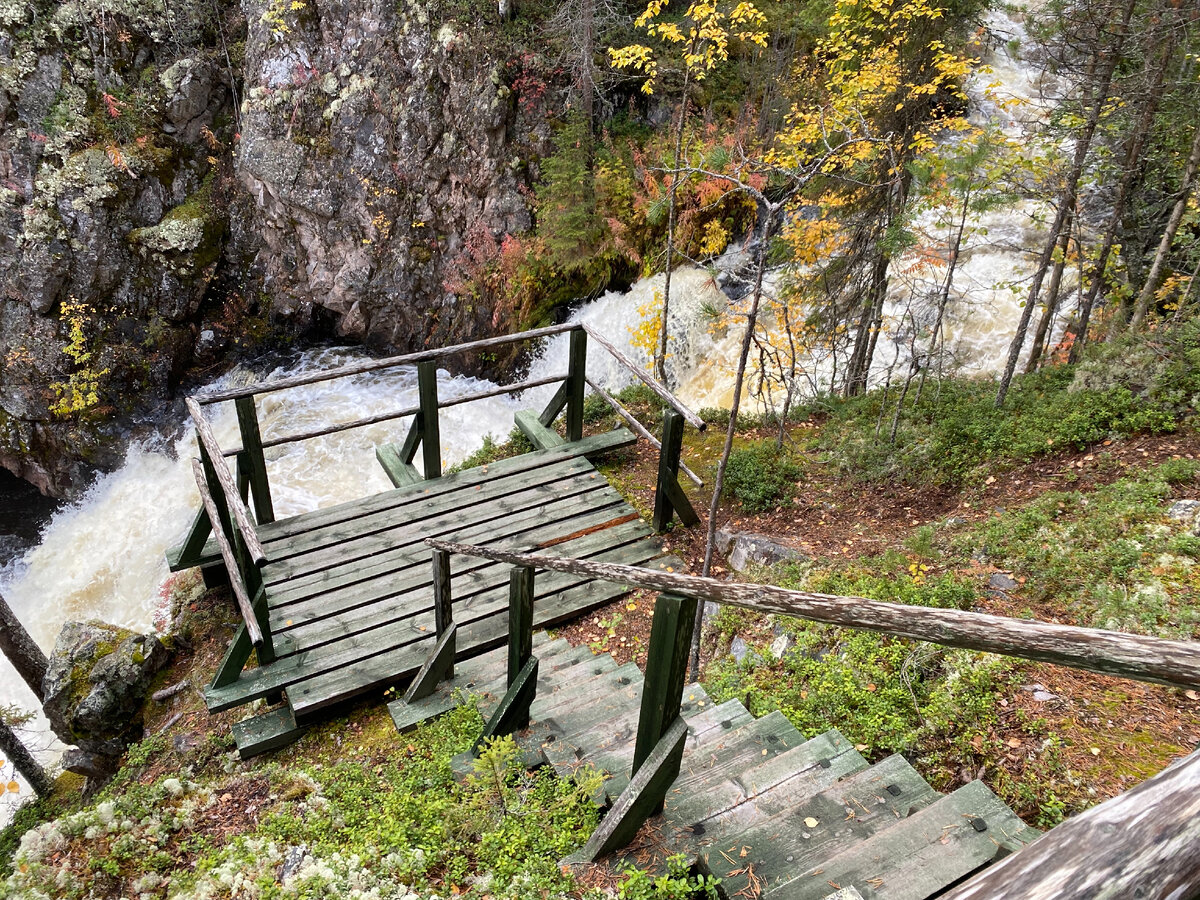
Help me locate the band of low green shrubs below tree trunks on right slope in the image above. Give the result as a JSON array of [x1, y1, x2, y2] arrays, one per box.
[[821, 323, 1200, 484]]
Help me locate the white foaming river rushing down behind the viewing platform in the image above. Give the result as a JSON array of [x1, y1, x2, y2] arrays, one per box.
[[0, 1, 1060, 820]]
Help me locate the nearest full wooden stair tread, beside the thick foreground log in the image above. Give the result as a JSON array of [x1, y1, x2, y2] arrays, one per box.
[[763, 781, 1038, 900]]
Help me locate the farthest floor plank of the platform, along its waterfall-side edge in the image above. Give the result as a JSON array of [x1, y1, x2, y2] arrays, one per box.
[[172, 428, 636, 565]]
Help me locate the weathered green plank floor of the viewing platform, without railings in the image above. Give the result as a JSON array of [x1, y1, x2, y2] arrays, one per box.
[[188, 430, 662, 751]]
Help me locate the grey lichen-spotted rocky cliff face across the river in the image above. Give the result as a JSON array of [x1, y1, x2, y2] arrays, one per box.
[[0, 0, 548, 493]]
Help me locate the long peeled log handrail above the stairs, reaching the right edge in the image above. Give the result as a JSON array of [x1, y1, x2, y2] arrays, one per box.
[[426, 539, 1200, 688]]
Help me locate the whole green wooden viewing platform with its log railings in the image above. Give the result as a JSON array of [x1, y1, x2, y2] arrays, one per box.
[[169, 328, 698, 756]]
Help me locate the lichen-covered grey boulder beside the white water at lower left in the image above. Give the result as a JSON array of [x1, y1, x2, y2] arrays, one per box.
[[42, 622, 169, 757]]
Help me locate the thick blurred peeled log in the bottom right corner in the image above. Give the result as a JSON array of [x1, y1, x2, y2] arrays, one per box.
[[942, 754, 1200, 900]]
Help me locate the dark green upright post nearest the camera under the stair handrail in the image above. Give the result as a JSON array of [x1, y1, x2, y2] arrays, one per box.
[[632, 592, 696, 775]]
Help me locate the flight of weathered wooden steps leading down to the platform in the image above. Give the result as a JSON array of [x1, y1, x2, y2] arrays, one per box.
[[390, 634, 1038, 900]]
